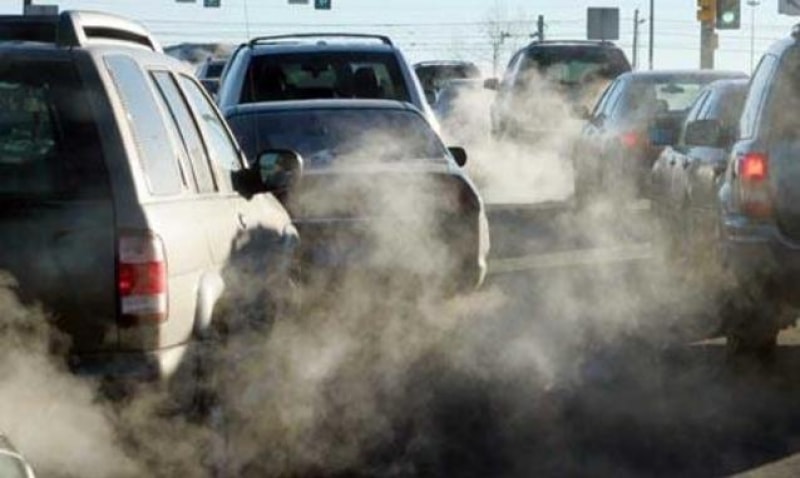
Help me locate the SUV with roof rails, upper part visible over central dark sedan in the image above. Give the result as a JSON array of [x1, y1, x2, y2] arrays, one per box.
[[217, 33, 438, 131]]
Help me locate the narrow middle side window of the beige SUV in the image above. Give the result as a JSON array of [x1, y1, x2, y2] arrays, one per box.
[[152, 71, 216, 192]]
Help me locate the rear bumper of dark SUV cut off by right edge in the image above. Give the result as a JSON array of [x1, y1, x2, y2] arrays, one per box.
[[724, 216, 800, 307]]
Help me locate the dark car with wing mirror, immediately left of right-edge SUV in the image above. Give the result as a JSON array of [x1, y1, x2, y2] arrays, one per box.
[[650, 79, 748, 260]]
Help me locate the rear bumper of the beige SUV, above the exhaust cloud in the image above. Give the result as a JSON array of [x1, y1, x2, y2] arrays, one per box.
[[69, 344, 189, 383]]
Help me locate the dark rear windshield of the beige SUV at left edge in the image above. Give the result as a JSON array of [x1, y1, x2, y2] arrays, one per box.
[[0, 57, 107, 198]]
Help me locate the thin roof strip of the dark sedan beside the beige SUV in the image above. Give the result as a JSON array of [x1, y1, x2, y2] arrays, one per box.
[[226, 99, 422, 116]]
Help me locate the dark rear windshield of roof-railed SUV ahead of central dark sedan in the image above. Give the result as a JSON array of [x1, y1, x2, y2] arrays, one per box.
[[241, 52, 410, 103]]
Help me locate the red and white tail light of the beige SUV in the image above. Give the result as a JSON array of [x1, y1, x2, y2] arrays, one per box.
[[117, 233, 168, 327]]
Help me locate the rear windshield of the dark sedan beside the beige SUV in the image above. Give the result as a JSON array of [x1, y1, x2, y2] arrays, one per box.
[[229, 109, 447, 167]]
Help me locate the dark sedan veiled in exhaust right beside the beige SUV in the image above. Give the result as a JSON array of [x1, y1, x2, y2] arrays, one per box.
[[225, 100, 489, 292]]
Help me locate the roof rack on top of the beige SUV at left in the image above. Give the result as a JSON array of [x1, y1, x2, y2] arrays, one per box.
[[0, 10, 162, 53]]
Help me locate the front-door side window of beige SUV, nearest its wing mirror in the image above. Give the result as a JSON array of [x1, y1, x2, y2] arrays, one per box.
[[180, 76, 242, 188]]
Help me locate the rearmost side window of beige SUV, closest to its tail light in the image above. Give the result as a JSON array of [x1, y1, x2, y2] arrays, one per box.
[[105, 55, 183, 196]]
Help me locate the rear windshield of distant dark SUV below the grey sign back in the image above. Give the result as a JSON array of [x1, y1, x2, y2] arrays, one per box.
[[520, 46, 631, 84]]
